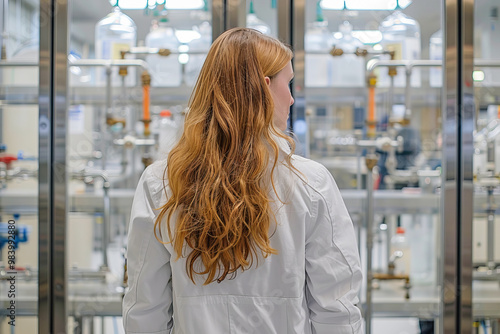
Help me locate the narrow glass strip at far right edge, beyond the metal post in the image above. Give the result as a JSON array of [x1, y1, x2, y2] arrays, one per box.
[[472, 0, 500, 333]]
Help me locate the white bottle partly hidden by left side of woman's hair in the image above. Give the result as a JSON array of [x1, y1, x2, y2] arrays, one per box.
[[185, 21, 212, 86]]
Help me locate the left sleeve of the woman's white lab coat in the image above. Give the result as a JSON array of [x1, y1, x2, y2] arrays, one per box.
[[122, 169, 173, 334]]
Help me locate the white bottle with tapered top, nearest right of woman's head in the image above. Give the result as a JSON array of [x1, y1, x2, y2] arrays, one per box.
[[304, 1, 333, 87]]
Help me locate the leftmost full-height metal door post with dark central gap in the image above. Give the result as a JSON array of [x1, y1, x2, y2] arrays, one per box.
[[38, 0, 68, 334]]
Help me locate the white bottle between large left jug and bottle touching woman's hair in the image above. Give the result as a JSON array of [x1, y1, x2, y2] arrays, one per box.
[[146, 16, 182, 87]]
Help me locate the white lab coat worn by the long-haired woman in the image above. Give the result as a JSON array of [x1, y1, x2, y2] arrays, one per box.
[[123, 137, 364, 334]]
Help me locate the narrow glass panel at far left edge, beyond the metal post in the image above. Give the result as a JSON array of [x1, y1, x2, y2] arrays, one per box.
[[0, 0, 40, 333]]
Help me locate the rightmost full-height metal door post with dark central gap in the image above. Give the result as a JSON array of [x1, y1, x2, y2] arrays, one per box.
[[440, 0, 474, 334]]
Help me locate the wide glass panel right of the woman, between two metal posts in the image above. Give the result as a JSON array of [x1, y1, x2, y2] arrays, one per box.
[[302, 0, 443, 333]]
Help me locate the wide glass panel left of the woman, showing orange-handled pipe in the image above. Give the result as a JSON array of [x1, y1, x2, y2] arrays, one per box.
[[67, 0, 212, 333]]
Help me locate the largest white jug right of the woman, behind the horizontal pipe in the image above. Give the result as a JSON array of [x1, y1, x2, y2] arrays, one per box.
[[378, 10, 421, 87]]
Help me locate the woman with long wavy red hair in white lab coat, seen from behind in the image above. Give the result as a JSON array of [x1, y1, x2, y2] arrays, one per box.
[[123, 28, 362, 334]]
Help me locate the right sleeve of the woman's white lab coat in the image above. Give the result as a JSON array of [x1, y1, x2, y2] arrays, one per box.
[[306, 169, 364, 334]]
